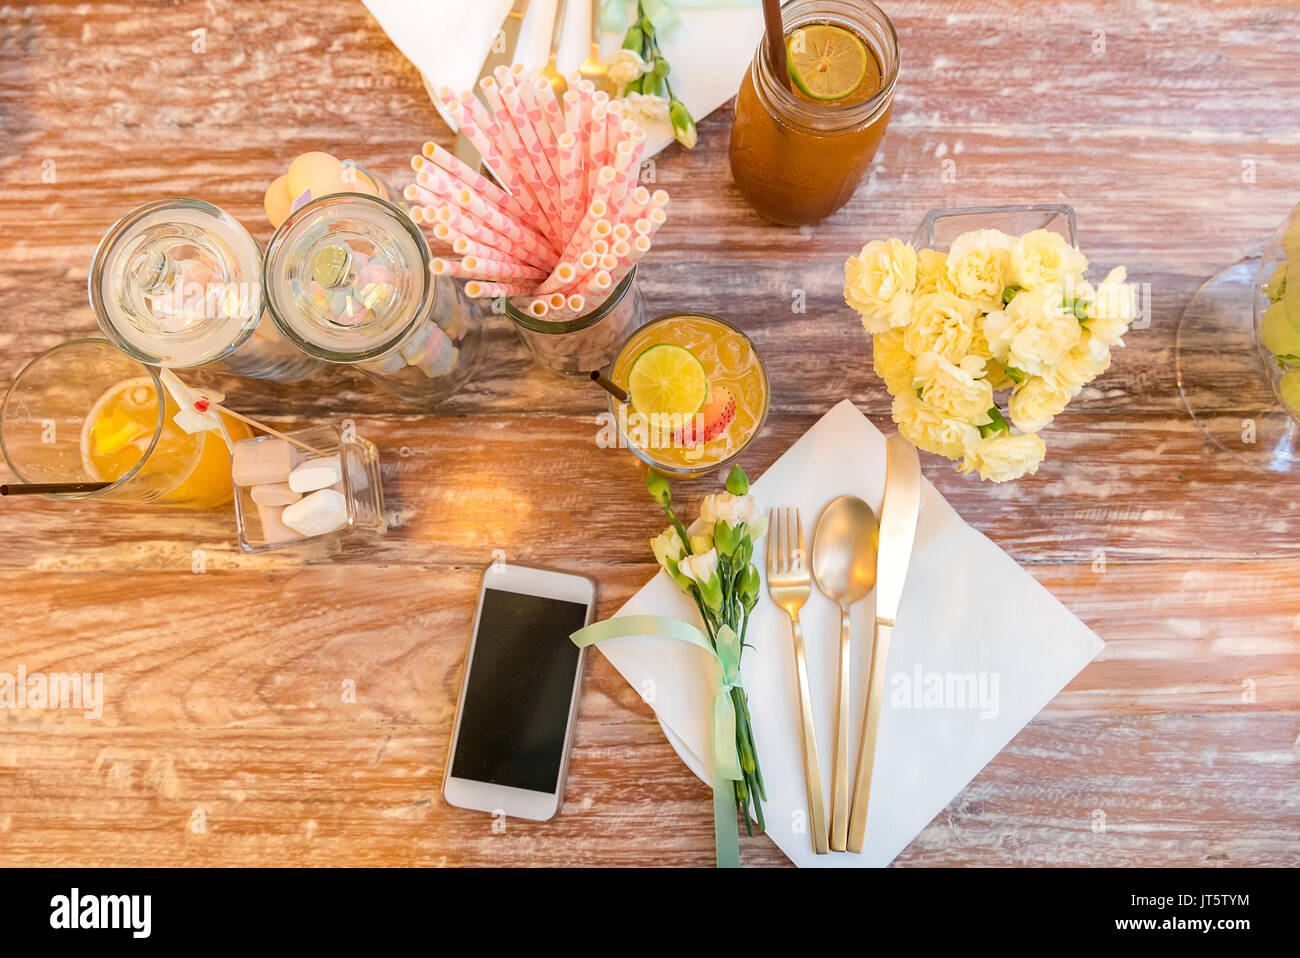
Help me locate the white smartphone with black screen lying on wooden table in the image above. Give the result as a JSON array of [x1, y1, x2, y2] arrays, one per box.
[[442, 563, 595, 822]]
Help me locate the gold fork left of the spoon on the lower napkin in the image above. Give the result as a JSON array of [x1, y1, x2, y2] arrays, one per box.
[[767, 508, 831, 855]]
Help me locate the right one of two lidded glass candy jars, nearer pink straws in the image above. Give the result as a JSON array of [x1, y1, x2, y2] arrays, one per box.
[[263, 192, 482, 406]]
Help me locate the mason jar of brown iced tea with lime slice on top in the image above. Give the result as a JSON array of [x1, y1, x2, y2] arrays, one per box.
[[731, 0, 898, 226]]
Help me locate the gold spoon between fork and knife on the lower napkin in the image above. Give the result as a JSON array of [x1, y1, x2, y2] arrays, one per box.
[[813, 495, 880, 851]]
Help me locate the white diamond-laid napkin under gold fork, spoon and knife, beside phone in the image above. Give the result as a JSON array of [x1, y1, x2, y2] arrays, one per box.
[[597, 400, 1102, 866]]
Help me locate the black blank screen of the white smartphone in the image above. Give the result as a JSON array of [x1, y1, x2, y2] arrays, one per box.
[[451, 589, 586, 793]]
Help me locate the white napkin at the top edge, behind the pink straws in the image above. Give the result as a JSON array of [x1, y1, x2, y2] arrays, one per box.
[[361, 0, 763, 156]]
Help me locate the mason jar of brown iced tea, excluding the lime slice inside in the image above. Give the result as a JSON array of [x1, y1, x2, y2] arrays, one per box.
[[731, 0, 898, 226]]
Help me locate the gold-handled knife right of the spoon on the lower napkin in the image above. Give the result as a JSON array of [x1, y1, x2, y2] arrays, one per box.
[[849, 433, 922, 851]]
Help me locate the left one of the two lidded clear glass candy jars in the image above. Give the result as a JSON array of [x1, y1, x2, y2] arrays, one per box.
[[88, 198, 324, 382]]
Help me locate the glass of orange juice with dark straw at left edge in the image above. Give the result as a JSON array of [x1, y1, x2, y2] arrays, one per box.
[[0, 339, 252, 508]]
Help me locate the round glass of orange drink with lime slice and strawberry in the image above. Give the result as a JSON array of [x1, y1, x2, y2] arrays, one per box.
[[610, 313, 768, 476]]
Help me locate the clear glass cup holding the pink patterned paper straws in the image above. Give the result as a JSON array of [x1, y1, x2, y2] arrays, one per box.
[[504, 266, 646, 376]]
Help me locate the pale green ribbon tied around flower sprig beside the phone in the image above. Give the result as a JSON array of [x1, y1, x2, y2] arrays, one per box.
[[569, 615, 744, 868]]
